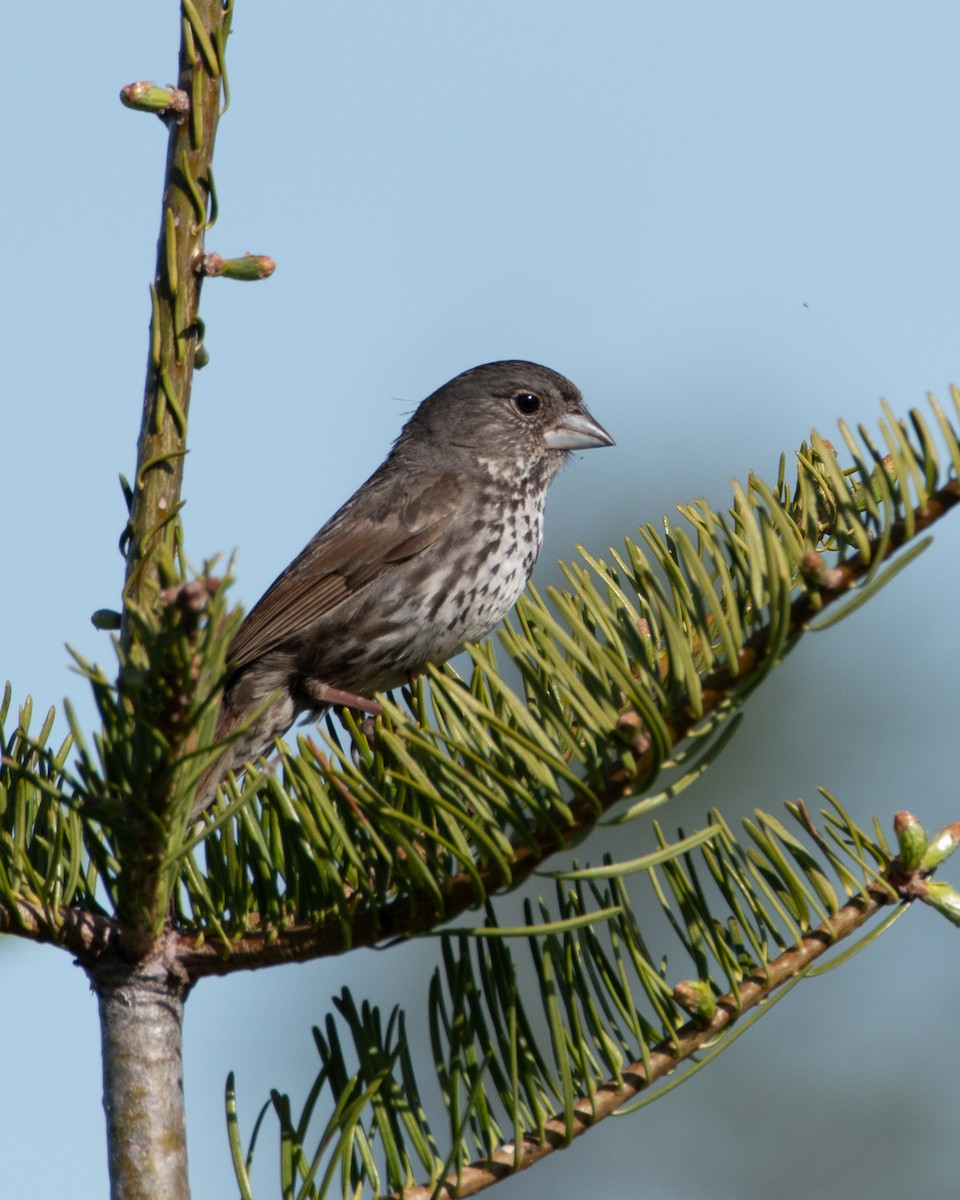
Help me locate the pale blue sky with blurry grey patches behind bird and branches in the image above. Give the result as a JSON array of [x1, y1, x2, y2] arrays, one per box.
[[0, 7, 960, 1200]]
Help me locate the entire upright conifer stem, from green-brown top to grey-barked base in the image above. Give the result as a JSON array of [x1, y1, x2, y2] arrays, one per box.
[[96, 7, 232, 1200]]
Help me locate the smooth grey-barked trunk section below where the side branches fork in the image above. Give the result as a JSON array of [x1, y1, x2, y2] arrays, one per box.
[[90, 953, 190, 1200]]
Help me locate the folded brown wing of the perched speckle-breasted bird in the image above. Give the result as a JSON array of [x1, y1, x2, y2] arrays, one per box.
[[227, 474, 460, 668]]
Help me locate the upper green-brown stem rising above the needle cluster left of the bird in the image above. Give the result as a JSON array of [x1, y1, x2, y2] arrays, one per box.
[[121, 0, 232, 646]]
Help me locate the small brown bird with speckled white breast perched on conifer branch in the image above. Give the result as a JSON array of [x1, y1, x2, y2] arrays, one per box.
[[191, 360, 614, 820]]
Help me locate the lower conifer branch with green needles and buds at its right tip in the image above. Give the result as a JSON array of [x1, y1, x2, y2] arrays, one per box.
[[227, 793, 960, 1200]]
